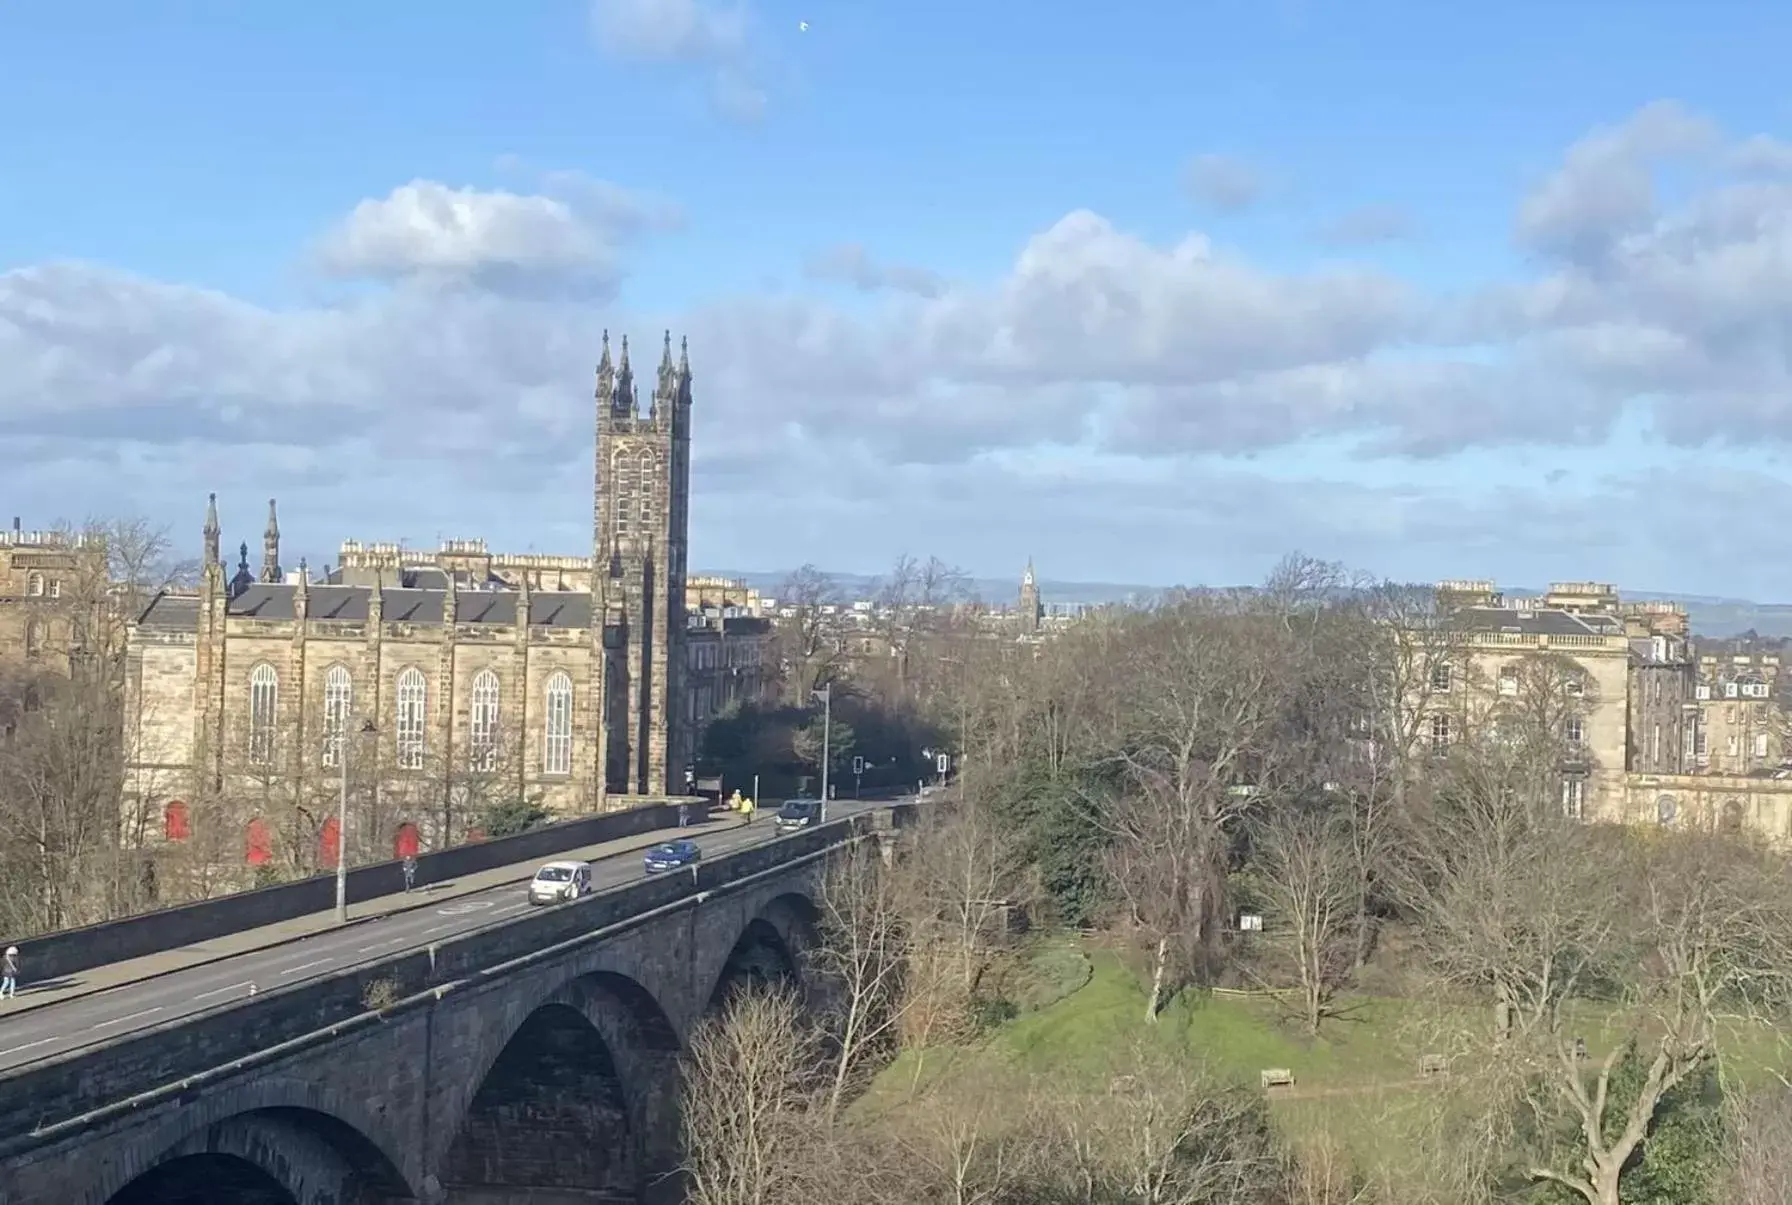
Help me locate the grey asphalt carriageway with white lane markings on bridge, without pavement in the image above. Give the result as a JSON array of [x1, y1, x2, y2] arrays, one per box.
[[0, 800, 889, 1076]]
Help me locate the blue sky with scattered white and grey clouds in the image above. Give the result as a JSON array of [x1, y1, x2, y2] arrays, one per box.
[[0, 0, 1792, 599]]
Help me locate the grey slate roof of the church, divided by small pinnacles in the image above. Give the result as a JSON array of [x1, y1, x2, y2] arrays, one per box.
[[138, 583, 591, 631]]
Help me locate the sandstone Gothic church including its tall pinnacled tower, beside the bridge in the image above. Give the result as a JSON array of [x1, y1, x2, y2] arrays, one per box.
[[125, 332, 702, 863]]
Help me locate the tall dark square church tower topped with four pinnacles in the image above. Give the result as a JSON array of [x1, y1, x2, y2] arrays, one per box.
[[591, 332, 692, 794]]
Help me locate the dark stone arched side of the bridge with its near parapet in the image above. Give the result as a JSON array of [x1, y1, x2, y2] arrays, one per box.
[[0, 818, 869, 1205]]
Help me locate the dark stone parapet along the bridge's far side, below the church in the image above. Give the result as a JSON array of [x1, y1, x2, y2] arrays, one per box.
[[17, 803, 677, 982]]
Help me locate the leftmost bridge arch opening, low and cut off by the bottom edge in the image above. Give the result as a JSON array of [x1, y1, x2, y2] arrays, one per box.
[[99, 1106, 414, 1205]]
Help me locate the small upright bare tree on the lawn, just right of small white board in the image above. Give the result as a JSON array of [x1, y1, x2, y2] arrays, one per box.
[[1253, 807, 1360, 1035]]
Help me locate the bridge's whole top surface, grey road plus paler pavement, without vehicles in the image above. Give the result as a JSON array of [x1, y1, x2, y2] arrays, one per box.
[[0, 800, 887, 1076]]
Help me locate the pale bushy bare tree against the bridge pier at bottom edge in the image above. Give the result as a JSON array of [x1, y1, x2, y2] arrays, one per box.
[[683, 990, 828, 1205]]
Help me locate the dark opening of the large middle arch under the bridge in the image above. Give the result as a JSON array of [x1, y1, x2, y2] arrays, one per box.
[[439, 970, 679, 1200]]
